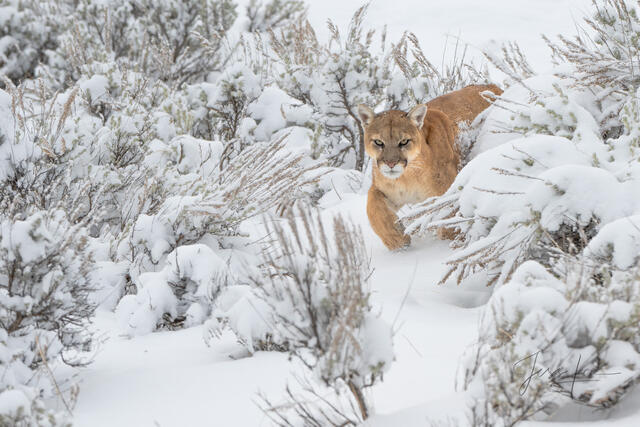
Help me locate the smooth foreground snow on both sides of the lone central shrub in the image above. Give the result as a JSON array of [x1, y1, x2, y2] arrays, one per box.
[[75, 195, 486, 427]]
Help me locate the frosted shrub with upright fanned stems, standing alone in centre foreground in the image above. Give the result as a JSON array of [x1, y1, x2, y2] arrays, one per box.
[[208, 209, 393, 424]]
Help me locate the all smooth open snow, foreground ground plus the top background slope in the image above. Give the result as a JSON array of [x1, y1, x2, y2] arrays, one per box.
[[66, 0, 640, 427]]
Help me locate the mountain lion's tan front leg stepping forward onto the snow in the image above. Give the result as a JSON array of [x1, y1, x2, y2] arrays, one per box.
[[367, 187, 411, 250]]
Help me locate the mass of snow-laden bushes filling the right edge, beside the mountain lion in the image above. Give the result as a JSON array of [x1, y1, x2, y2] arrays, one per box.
[[404, 0, 640, 426]]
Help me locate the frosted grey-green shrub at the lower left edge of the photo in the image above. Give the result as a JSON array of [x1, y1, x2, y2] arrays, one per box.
[[0, 176, 95, 425]]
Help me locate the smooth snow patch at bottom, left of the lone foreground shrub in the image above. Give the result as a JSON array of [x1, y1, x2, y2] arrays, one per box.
[[74, 312, 290, 427]]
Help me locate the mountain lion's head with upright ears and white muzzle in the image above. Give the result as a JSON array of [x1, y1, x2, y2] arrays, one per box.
[[358, 104, 427, 179]]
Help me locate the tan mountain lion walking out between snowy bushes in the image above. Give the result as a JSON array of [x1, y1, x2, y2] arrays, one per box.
[[358, 85, 502, 250]]
